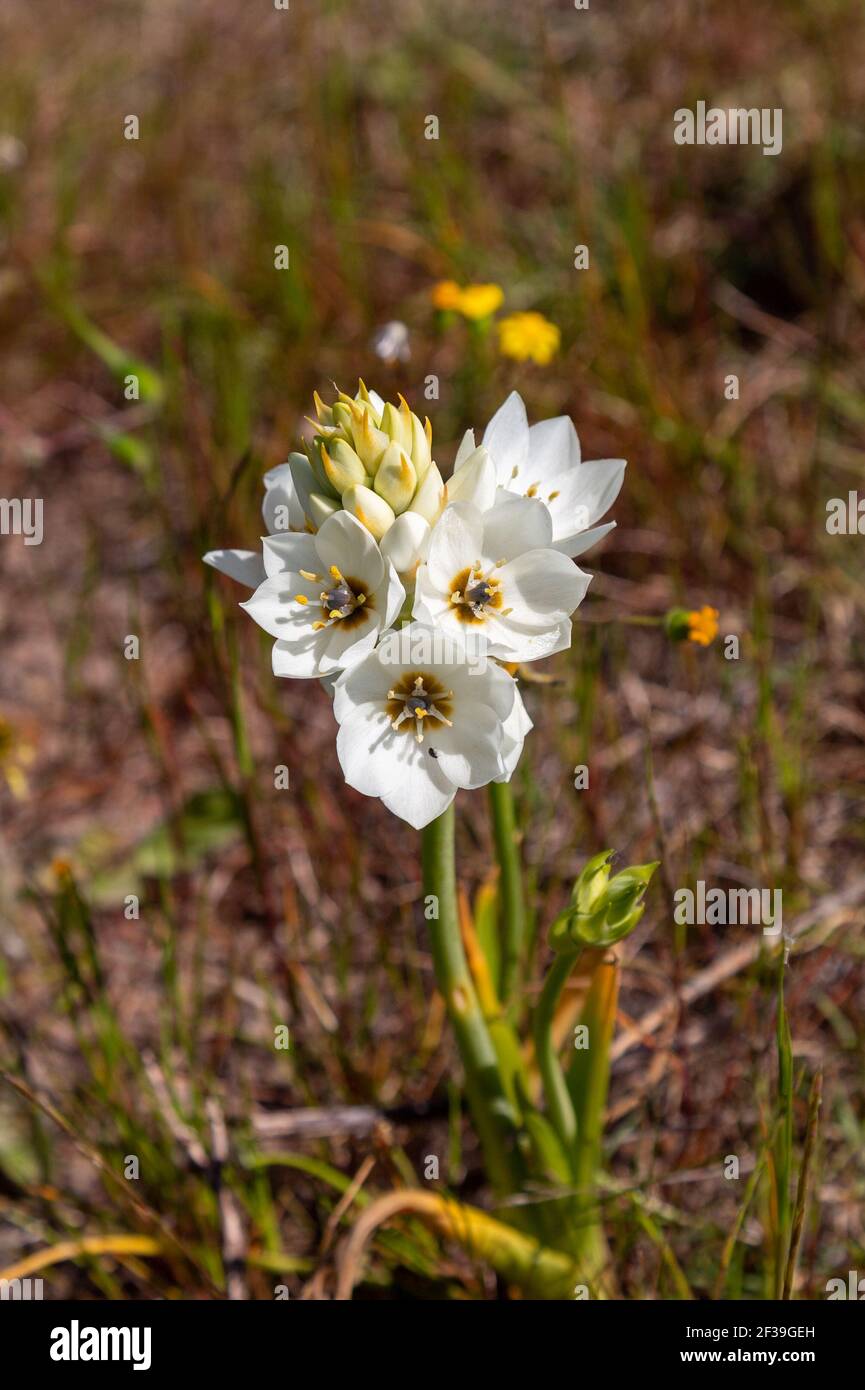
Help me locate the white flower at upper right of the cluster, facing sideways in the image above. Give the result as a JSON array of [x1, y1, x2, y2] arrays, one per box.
[[448, 391, 626, 559]]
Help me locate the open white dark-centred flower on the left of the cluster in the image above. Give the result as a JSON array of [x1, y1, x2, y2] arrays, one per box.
[[241, 512, 405, 677]]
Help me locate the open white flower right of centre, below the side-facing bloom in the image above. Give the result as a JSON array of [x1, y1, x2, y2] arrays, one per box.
[[413, 492, 590, 662]]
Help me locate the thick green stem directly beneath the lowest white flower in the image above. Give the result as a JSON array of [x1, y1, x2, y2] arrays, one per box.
[[423, 806, 522, 1195]]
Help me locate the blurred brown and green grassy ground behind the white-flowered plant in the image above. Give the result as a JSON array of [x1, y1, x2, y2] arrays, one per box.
[[0, 0, 865, 1298]]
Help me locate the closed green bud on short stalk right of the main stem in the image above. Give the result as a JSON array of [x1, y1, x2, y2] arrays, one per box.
[[549, 849, 659, 951]]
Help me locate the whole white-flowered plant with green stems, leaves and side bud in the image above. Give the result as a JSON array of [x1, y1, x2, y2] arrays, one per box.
[[204, 382, 655, 1297]]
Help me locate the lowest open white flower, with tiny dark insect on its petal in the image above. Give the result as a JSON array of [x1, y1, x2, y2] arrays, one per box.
[[334, 623, 531, 830]]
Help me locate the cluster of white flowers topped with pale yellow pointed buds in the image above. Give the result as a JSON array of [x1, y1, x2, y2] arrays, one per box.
[[204, 382, 624, 828]]
